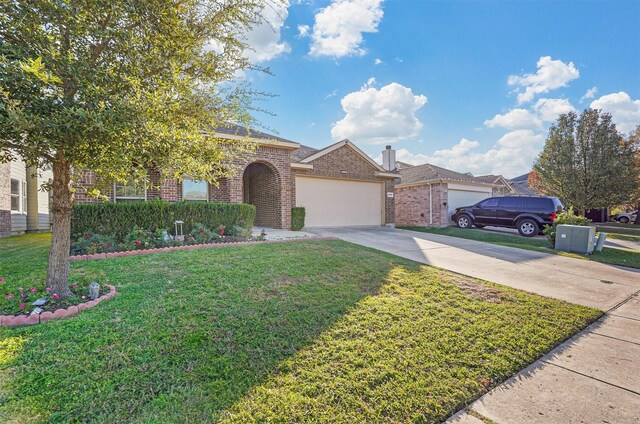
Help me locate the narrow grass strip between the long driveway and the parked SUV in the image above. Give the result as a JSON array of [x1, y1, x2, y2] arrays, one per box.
[[398, 227, 640, 268]]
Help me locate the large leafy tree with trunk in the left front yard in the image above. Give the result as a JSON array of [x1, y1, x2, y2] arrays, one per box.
[[0, 0, 272, 296]]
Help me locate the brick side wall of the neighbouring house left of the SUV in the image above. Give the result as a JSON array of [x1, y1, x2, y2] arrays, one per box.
[[395, 184, 449, 227]]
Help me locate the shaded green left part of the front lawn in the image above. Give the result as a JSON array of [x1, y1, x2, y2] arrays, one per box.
[[0, 242, 410, 422]]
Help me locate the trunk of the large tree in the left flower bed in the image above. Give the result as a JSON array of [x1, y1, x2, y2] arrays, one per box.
[[47, 150, 73, 298]]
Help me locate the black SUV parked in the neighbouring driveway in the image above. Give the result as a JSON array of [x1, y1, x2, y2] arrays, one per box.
[[452, 196, 565, 237]]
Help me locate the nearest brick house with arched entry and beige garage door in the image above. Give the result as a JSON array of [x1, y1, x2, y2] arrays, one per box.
[[76, 126, 398, 228]]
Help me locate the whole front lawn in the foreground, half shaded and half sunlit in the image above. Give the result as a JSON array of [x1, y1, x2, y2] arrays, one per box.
[[0, 235, 601, 423]]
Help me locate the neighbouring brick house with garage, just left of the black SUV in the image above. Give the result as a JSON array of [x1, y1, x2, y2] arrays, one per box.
[[395, 163, 508, 227]]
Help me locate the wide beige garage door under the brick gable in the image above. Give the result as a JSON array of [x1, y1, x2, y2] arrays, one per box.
[[296, 177, 383, 227]]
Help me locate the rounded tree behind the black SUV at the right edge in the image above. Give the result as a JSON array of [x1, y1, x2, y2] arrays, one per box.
[[532, 109, 638, 211]]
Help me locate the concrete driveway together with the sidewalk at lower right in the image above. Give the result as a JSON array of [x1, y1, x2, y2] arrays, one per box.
[[306, 227, 640, 424]]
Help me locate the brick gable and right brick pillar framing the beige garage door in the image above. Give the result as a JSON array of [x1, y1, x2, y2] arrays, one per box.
[[294, 146, 396, 223]]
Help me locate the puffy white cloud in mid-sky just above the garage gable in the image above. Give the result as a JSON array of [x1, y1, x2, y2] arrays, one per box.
[[331, 78, 427, 144]]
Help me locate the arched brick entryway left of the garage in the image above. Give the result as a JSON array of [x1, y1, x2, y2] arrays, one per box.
[[242, 162, 282, 228]]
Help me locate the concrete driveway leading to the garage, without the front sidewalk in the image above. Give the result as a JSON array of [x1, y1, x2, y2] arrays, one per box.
[[305, 227, 640, 311]]
